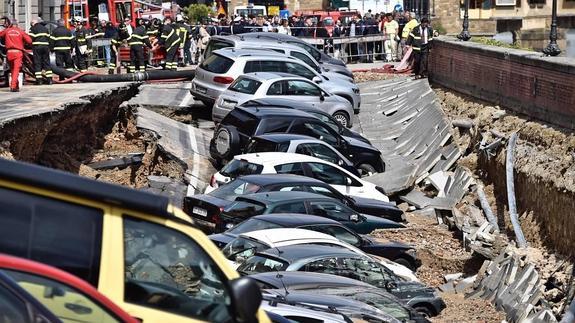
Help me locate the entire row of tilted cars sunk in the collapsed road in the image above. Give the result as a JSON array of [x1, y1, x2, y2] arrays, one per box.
[[184, 32, 445, 322]]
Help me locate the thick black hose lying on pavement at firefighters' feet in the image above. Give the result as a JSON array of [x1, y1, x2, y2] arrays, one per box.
[[52, 65, 196, 83]]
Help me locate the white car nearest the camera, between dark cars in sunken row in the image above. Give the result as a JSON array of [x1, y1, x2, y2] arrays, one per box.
[[222, 228, 418, 281]]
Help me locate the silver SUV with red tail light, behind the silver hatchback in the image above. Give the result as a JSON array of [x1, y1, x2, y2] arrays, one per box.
[[190, 48, 361, 113]]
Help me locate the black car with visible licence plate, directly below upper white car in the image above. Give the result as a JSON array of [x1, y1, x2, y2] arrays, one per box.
[[184, 174, 405, 231]]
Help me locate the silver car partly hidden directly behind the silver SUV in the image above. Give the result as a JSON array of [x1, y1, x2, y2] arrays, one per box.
[[204, 34, 353, 78]]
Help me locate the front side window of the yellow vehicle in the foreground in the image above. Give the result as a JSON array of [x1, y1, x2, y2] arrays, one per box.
[[124, 216, 233, 322]]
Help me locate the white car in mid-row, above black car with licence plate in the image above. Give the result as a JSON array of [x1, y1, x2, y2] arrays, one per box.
[[205, 152, 389, 202]]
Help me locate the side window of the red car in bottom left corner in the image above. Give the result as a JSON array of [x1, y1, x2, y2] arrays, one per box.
[[0, 270, 120, 323]]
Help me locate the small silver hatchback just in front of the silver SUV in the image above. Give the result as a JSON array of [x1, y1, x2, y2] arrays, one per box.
[[212, 72, 353, 127]]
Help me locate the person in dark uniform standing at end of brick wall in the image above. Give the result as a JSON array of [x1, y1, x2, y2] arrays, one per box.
[[406, 17, 433, 78]]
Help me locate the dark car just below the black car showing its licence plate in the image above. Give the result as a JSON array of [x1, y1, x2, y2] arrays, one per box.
[[215, 191, 404, 234]]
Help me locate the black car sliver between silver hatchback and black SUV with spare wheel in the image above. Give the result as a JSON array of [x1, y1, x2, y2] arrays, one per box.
[[239, 98, 371, 145]]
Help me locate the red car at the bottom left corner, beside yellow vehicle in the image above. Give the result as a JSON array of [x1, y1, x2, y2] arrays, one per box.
[[0, 254, 139, 323]]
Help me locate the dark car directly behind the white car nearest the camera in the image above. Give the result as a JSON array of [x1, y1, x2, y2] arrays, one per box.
[[208, 214, 421, 271]]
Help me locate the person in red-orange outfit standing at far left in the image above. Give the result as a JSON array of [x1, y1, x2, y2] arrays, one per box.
[[0, 17, 32, 92]]
